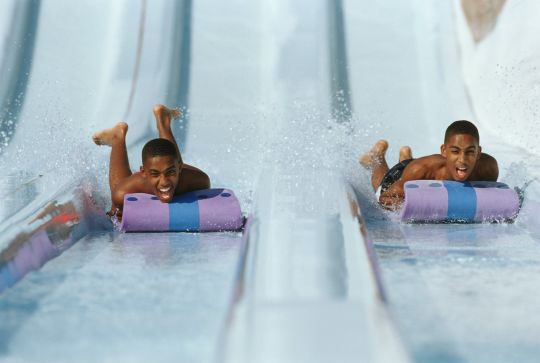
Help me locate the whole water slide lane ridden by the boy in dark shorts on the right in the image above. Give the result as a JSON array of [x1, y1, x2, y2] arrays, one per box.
[[345, 1, 540, 362]]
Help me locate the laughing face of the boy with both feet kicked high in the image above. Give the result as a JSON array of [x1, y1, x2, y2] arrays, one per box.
[[141, 155, 182, 203]]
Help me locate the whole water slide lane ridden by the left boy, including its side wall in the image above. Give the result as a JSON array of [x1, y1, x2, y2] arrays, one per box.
[[0, 1, 246, 362]]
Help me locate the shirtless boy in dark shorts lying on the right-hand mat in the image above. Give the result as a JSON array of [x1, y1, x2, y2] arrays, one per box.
[[360, 120, 499, 210]]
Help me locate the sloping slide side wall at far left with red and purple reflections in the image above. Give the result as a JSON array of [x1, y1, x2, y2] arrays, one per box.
[[0, 178, 112, 294]]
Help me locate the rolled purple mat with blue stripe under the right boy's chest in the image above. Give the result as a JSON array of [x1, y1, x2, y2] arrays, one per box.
[[401, 180, 519, 222]]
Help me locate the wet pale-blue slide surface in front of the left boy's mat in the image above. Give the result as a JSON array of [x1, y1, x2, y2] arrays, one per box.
[[0, 232, 241, 362]]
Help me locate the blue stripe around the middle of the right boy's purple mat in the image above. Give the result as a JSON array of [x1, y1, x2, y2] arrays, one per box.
[[443, 180, 476, 221]]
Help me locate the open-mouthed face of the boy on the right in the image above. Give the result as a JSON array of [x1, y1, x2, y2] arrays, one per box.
[[441, 134, 482, 181]]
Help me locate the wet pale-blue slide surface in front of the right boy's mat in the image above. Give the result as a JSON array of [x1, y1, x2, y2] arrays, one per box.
[[367, 219, 540, 362]]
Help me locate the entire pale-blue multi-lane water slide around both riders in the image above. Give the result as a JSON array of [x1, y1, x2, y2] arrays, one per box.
[[0, 0, 540, 362]]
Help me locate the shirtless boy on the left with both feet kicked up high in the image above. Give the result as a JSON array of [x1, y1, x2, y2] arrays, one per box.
[[92, 105, 210, 219]]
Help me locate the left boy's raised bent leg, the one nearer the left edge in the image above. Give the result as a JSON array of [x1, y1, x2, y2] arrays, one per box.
[[92, 122, 132, 193]]
